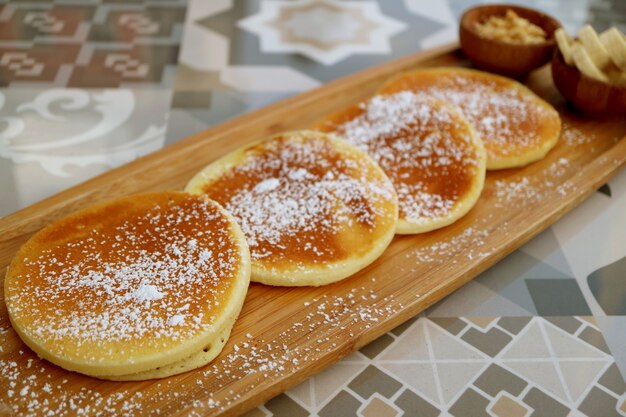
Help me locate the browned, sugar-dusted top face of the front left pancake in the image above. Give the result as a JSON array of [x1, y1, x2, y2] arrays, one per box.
[[8, 197, 241, 351]]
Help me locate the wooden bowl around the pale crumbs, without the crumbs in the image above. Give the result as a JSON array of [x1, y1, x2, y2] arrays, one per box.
[[459, 4, 561, 76]]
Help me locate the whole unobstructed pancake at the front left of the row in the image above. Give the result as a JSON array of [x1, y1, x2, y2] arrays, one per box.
[[4, 192, 250, 379]]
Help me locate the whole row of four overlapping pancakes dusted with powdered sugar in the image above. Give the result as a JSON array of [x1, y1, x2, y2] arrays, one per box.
[[5, 68, 560, 380]]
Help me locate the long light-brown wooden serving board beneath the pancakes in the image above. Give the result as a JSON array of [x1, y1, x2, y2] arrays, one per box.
[[0, 45, 626, 416]]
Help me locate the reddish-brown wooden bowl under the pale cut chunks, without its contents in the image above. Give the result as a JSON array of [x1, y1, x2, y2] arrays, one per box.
[[552, 48, 626, 117]]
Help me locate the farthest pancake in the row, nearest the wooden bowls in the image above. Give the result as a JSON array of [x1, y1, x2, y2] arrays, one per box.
[[378, 68, 561, 170]]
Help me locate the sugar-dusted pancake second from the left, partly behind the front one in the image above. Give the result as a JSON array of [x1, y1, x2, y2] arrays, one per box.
[[186, 131, 398, 286]]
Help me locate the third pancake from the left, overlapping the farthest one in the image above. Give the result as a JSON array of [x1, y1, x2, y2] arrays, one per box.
[[316, 91, 486, 234]]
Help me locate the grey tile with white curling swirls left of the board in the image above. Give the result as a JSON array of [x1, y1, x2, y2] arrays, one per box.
[[0, 87, 171, 211]]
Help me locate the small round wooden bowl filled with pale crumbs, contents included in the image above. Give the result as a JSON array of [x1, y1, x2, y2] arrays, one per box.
[[459, 4, 561, 77]]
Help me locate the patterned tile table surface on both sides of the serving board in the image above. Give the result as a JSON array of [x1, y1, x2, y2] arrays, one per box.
[[0, 0, 626, 417]]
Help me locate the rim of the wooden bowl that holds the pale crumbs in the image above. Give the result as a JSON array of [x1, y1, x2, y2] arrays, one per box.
[[459, 3, 563, 49]]
